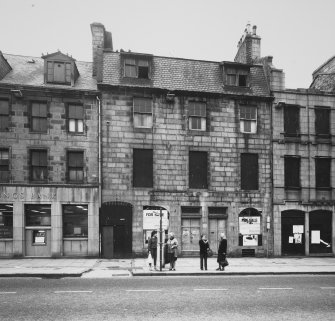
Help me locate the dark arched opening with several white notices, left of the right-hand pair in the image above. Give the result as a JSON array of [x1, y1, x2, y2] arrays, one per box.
[[281, 210, 305, 255]]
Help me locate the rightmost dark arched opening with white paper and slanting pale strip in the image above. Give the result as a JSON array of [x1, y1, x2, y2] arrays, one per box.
[[309, 210, 332, 254]]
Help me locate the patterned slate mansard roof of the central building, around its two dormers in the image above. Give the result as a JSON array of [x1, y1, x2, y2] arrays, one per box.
[[102, 51, 270, 96]]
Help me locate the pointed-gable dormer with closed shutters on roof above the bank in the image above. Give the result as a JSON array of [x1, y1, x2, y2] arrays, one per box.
[[42, 51, 79, 86]]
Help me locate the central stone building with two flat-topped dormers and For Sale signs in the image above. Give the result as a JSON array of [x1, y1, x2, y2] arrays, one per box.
[[91, 23, 273, 257]]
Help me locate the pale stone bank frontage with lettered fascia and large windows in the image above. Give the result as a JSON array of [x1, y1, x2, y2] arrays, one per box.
[[0, 186, 99, 257]]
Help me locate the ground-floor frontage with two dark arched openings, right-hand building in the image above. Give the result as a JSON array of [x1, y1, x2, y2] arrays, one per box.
[[273, 201, 335, 256]]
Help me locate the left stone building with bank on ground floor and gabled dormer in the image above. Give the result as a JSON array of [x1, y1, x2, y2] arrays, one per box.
[[0, 52, 99, 257]]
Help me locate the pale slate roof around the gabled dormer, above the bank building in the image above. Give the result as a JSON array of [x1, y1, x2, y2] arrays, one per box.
[[0, 54, 97, 90]]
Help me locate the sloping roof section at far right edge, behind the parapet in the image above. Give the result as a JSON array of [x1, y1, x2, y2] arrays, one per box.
[[310, 56, 335, 92]]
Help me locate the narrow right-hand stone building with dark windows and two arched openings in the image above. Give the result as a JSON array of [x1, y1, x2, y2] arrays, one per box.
[[269, 57, 335, 256]]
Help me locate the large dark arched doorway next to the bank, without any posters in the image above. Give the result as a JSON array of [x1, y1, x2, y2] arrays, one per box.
[[100, 202, 133, 259]]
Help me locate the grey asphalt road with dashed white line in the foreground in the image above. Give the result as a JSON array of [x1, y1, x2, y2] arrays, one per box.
[[0, 276, 335, 321]]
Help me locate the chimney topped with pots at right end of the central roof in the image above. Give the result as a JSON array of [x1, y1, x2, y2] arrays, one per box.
[[234, 23, 261, 64]]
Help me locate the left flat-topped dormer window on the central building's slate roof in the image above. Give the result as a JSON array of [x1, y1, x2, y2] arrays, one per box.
[[123, 54, 150, 79]]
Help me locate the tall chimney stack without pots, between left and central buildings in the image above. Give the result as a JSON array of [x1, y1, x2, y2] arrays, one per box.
[[91, 22, 113, 81]]
